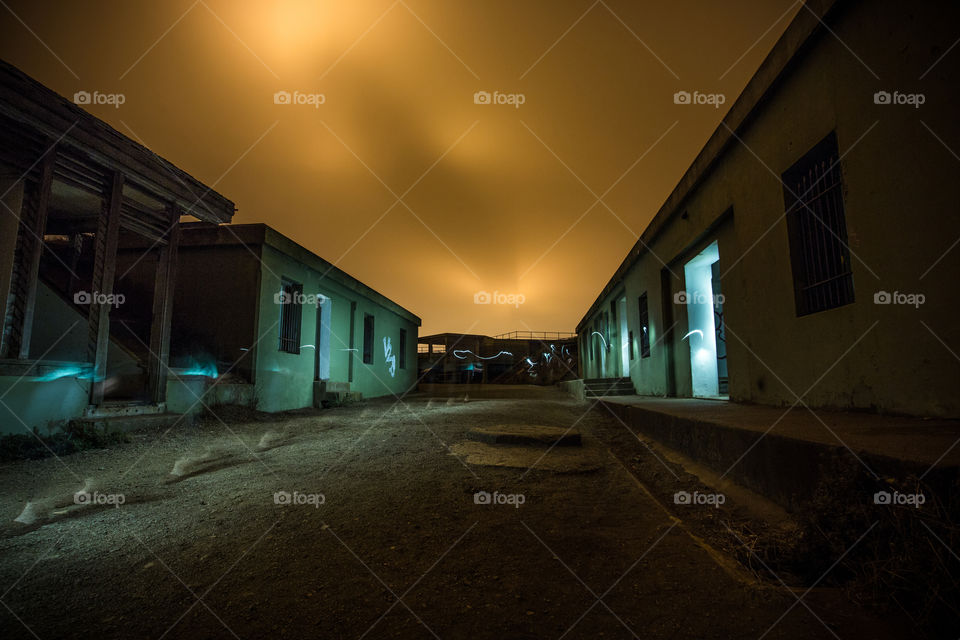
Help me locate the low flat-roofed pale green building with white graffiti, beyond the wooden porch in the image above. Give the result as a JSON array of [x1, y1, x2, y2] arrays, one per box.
[[170, 223, 420, 411]]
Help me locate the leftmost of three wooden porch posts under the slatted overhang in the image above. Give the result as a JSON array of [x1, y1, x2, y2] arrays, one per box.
[[18, 148, 57, 360]]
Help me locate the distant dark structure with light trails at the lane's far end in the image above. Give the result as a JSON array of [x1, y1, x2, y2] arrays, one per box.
[[417, 331, 578, 385]]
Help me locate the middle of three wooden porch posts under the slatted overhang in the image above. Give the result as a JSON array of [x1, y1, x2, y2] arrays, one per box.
[[89, 171, 123, 405]]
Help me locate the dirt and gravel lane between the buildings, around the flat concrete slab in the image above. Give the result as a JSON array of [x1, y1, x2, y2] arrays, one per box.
[[0, 392, 904, 640]]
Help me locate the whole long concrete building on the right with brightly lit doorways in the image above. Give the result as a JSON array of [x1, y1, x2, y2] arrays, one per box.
[[577, 0, 960, 417]]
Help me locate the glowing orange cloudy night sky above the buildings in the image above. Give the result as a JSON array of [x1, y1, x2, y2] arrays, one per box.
[[0, 0, 799, 334]]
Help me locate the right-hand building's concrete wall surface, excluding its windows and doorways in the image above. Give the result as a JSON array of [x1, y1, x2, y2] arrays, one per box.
[[581, 1, 960, 416]]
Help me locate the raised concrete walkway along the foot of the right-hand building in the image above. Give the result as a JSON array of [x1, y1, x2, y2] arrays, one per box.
[[601, 396, 960, 510]]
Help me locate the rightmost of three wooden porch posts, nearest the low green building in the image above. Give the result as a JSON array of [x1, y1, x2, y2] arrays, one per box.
[[147, 206, 180, 403]]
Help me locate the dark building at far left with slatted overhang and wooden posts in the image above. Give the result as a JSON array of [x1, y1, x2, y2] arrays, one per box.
[[0, 62, 234, 433]]
